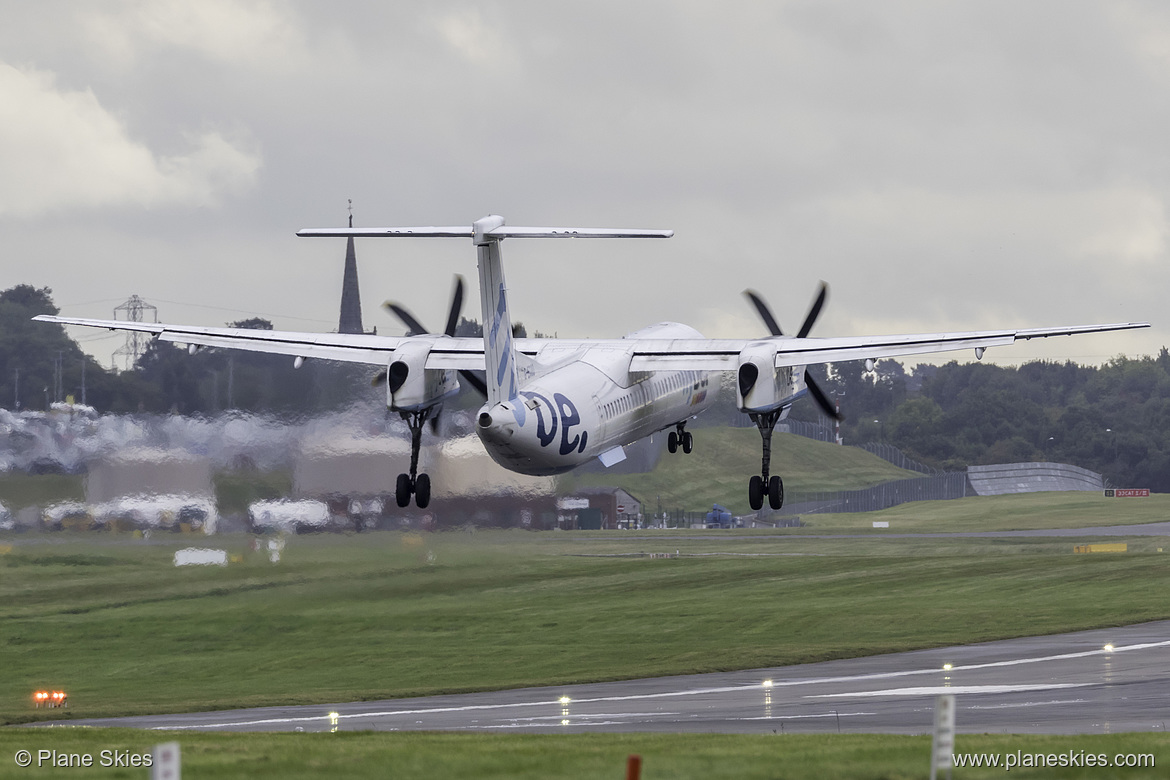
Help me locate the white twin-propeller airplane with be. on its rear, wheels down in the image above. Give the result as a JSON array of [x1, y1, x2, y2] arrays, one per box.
[[34, 215, 1149, 510]]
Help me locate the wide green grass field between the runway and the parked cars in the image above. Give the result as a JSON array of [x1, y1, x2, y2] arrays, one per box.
[[0, 519, 1170, 723]]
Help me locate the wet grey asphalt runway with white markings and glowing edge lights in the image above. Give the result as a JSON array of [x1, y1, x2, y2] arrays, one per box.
[[40, 621, 1170, 734]]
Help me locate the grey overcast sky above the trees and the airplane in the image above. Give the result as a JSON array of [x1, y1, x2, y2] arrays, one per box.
[[0, 0, 1170, 365]]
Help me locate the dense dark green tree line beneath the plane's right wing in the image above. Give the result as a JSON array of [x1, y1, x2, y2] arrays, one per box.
[[804, 355, 1170, 492]]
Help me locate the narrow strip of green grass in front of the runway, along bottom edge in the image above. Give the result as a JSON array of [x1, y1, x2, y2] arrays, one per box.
[[0, 729, 1170, 780]]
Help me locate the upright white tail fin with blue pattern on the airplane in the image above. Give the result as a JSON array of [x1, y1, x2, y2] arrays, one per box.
[[473, 215, 517, 406]]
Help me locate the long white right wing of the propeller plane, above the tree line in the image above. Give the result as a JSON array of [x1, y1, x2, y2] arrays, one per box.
[[627, 323, 1150, 371]]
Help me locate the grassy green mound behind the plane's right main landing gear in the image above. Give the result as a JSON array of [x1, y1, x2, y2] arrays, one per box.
[[562, 428, 922, 515]]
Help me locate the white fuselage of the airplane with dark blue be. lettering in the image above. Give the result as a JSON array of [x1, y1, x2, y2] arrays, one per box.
[[476, 323, 718, 476]]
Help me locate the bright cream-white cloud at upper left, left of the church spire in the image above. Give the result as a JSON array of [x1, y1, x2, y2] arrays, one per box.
[[0, 62, 260, 218]]
